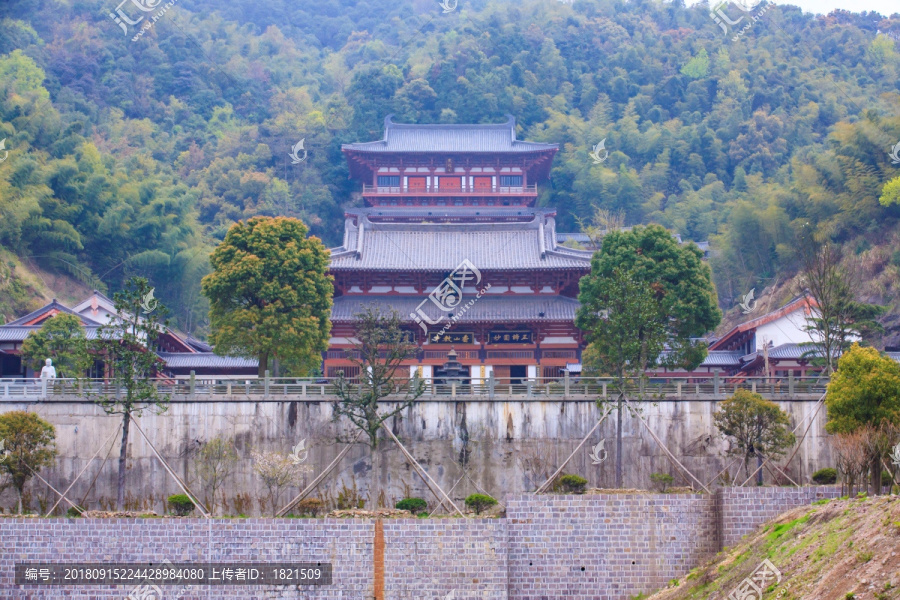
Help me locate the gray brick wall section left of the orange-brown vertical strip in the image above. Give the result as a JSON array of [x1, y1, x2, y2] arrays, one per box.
[[0, 519, 374, 600]]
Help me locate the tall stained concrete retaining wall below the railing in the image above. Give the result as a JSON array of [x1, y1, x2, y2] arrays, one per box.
[[0, 399, 833, 514]]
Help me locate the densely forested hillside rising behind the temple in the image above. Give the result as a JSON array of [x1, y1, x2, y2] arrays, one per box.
[[0, 0, 900, 334]]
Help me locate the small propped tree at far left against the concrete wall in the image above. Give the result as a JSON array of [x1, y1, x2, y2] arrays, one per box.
[[0, 410, 56, 514]]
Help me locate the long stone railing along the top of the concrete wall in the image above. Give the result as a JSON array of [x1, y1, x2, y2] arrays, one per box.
[[0, 373, 828, 405]]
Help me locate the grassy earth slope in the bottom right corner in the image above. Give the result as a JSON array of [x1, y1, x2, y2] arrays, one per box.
[[650, 496, 900, 600]]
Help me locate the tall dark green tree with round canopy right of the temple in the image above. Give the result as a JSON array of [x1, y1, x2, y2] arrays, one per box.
[[575, 225, 722, 486]]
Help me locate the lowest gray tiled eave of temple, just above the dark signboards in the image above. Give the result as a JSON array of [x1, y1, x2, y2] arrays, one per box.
[[331, 294, 578, 329]]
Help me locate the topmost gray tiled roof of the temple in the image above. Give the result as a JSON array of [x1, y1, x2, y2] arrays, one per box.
[[341, 115, 559, 152]]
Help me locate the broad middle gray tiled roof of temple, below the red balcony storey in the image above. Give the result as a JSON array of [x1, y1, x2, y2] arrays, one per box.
[[331, 213, 591, 272]]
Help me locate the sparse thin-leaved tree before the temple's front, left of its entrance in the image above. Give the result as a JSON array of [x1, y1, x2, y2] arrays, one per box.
[[333, 306, 425, 449]]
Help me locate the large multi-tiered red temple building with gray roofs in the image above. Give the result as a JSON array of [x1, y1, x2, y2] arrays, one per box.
[[324, 116, 591, 380]]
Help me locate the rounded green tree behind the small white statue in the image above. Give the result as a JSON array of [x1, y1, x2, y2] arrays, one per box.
[[22, 313, 93, 378]]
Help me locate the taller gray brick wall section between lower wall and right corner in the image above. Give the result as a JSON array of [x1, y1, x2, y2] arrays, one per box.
[[506, 494, 718, 600]]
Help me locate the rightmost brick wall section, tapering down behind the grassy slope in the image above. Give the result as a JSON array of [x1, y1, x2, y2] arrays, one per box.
[[716, 485, 841, 546]]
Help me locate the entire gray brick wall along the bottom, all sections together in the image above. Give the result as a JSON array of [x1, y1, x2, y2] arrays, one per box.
[[0, 486, 839, 600]]
